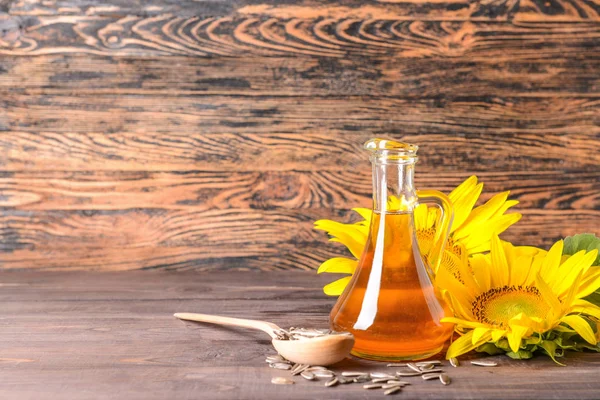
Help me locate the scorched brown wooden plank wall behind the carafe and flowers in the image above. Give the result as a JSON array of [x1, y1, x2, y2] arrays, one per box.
[[0, 0, 600, 270]]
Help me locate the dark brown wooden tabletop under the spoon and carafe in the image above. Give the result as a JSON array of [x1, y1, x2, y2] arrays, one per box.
[[0, 271, 600, 400]]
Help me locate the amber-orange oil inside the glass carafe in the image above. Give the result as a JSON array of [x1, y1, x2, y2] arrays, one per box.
[[331, 213, 453, 360]]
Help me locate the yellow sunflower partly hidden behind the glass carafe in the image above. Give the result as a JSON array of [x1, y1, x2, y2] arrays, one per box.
[[315, 176, 521, 296]]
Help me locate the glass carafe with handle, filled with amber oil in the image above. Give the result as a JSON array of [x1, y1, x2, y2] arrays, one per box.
[[330, 139, 453, 361]]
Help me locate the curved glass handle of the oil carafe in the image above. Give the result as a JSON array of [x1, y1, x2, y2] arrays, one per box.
[[417, 190, 454, 274]]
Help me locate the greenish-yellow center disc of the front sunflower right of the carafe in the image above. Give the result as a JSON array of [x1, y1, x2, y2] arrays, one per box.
[[472, 286, 550, 327]]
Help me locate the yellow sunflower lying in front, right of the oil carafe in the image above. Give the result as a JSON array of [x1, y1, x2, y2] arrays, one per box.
[[437, 236, 600, 359]]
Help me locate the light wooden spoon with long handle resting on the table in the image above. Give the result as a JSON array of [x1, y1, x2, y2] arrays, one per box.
[[174, 313, 354, 366]]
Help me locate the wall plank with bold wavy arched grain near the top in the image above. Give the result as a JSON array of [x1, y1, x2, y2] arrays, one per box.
[[0, 14, 599, 61]]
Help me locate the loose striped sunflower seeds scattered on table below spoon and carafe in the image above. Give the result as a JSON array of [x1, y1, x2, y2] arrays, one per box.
[[265, 354, 472, 395]]
